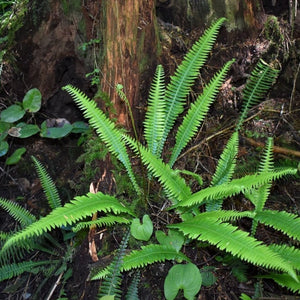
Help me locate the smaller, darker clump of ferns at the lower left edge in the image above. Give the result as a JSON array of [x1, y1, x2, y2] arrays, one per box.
[[0, 157, 74, 296]]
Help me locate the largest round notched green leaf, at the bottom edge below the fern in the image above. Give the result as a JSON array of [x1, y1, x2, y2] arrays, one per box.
[[164, 263, 202, 300]]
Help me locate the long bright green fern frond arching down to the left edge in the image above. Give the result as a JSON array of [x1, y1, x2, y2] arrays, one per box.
[[0, 192, 133, 259]]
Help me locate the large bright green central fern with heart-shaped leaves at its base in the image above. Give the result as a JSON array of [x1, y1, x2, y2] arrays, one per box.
[[0, 18, 300, 300]]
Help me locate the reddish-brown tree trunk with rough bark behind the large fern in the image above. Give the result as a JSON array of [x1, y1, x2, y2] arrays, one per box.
[[100, 0, 158, 127]]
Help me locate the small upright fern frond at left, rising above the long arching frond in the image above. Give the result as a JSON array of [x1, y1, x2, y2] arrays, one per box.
[[31, 156, 61, 209]]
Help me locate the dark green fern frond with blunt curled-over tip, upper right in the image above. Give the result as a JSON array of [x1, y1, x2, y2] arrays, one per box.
[[237, 59, 279, 130]]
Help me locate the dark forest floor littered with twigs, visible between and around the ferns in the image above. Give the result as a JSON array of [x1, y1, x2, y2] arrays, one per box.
[[0, 6, 300, 300]]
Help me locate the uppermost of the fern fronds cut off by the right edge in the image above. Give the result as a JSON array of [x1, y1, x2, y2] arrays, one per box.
[[255, 210, 300, 241]]
